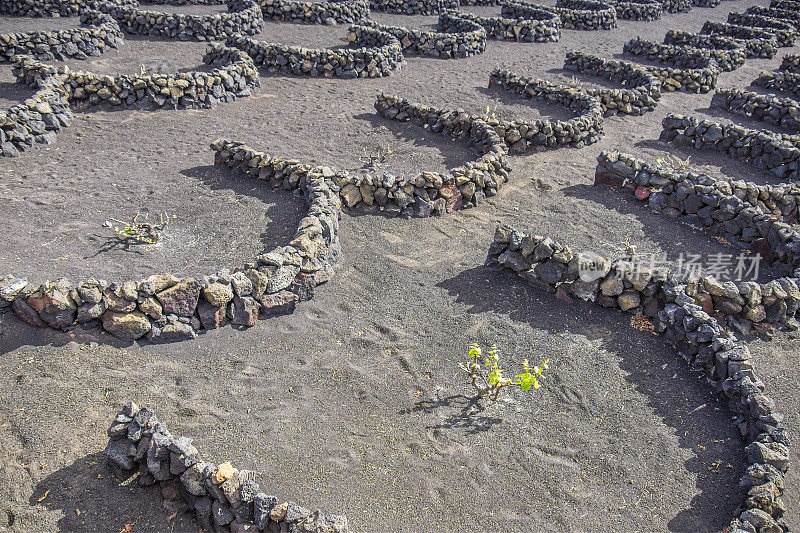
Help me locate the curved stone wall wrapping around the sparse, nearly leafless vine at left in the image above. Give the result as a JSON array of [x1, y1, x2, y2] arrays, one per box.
[[0, 140, 341, 342]]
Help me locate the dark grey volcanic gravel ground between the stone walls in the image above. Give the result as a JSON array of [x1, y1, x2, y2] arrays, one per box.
[[0, 0, 800, 532]]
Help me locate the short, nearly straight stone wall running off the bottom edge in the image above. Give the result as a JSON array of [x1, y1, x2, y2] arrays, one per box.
[[103, 402, 349, 533]]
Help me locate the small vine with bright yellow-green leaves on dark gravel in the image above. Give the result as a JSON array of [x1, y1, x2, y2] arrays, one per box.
[[458, 344, 550, 401]]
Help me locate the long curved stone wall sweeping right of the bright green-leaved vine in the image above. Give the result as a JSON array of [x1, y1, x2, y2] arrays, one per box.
[[487, 225, 789, 533]]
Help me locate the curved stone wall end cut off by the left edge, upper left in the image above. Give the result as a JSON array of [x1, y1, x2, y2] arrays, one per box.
[[0, 56, 72, 157]]
